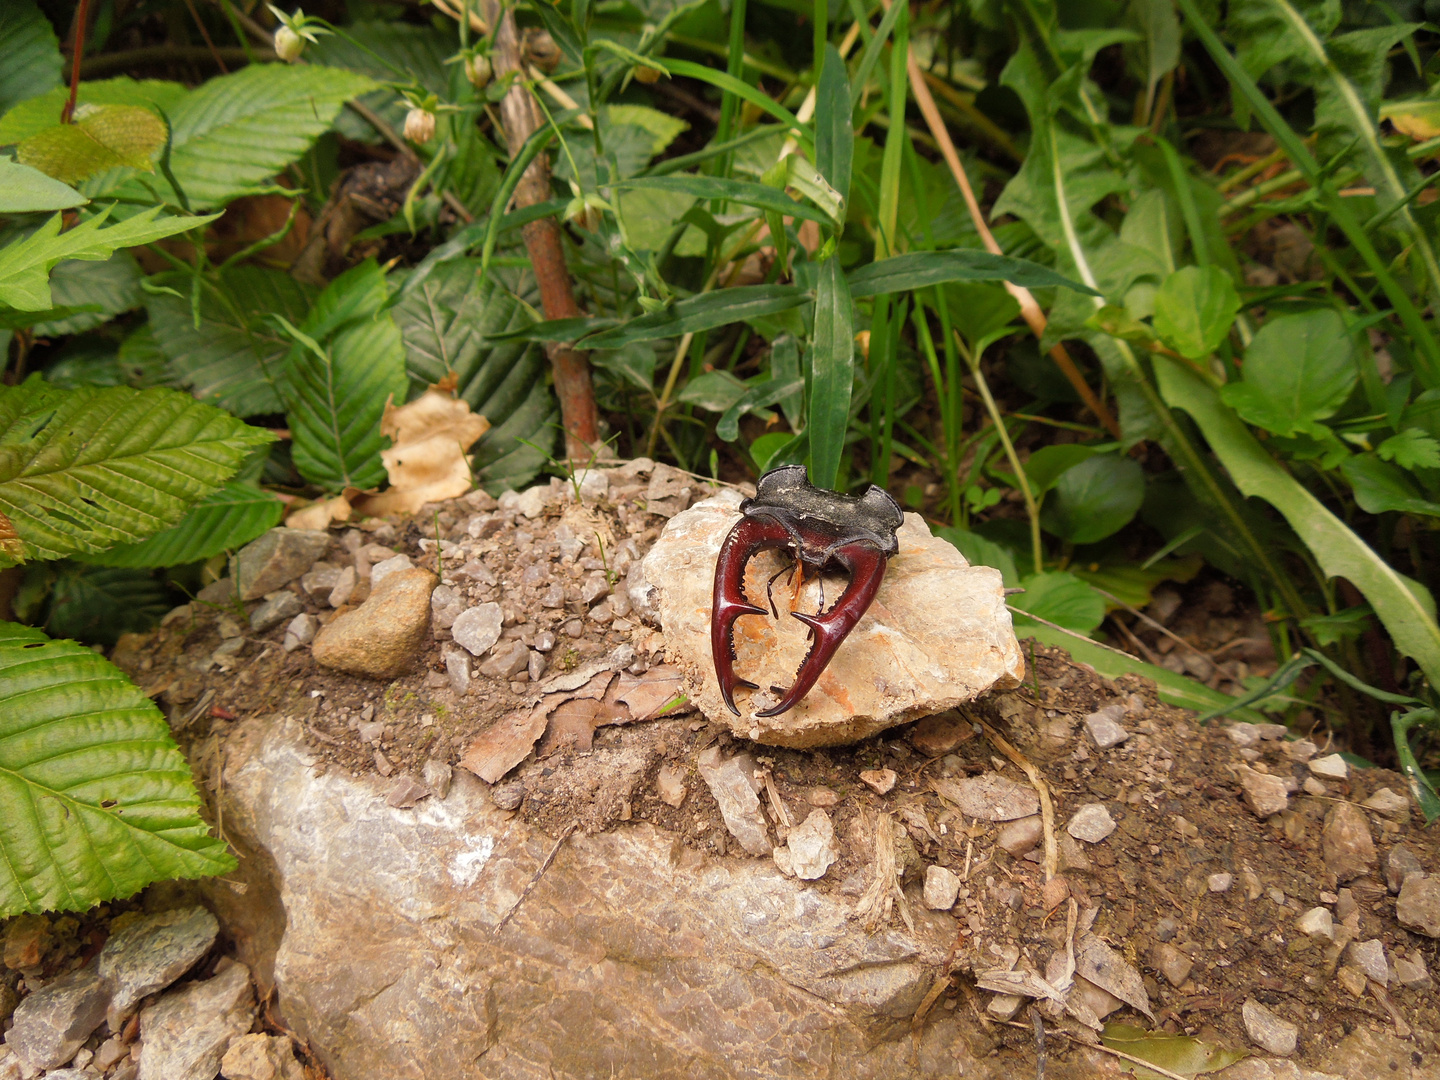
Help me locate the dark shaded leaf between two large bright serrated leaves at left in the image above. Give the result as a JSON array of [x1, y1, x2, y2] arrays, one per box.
[[45, 560, 174, 648]]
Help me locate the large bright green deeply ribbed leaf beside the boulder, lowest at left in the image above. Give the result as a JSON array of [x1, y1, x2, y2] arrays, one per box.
[[0, 622, 235, 917]]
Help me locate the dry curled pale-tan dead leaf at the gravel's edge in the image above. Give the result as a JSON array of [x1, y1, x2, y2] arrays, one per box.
[[357, 380, 490, 516]]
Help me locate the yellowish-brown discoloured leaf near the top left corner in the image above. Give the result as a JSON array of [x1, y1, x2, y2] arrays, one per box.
[[16, 105, 166, 184]]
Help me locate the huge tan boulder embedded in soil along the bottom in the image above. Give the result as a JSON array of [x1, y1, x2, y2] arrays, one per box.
[[215, 716, 990, 1080]]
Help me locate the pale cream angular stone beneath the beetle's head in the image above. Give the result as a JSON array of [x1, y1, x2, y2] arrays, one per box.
[[642, 491, 1025, 747]]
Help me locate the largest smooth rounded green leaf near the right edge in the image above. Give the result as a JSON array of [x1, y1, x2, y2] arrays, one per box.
[[1220, 310, 1358, 435]]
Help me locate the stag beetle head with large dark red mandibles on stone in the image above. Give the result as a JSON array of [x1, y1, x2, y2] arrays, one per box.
[[710, 465, 904, 716]]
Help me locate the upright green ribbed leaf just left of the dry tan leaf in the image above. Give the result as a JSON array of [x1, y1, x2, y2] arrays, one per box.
[[276, 259, 408, 491]]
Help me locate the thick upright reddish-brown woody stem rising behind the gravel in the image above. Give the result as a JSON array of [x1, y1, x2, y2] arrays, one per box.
[[485, 0, 600, 461]]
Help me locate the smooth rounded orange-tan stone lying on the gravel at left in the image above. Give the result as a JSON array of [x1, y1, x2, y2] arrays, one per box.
[[310, 569, 436, 678]]
